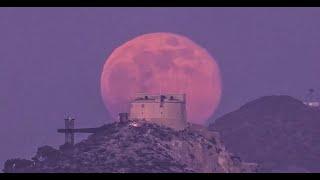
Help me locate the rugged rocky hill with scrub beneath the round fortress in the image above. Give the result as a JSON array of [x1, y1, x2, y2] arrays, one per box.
[[3, 121, 257, 173]]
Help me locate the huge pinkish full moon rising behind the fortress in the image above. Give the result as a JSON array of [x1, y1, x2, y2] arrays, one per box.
[[101, 32, 221, 124]]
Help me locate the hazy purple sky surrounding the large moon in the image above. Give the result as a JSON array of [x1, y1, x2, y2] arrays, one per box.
[[0, 8, 320, 167]]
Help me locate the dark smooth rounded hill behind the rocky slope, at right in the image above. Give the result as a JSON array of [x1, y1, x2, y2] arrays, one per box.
[[209, 96, 320, 172]]
